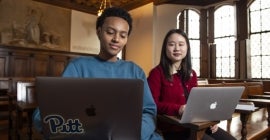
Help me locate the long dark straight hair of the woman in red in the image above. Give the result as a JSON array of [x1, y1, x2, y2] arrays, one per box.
[[159, 29, 192, 82]]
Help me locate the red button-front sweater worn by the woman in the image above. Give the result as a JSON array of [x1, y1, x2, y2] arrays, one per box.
[[147, 65, 198, 132]]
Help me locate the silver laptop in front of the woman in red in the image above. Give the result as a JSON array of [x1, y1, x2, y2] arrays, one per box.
[[180, 86, 245, 123]]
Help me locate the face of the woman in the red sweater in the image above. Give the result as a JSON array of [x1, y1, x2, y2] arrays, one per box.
[[166, 33, 188, 63]]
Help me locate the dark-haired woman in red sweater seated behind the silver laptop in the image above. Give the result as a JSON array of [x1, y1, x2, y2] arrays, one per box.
[[147, 29, 235, 140]]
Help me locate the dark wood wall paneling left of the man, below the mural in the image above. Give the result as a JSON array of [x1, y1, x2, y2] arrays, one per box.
[[0, 45, 94, 77]]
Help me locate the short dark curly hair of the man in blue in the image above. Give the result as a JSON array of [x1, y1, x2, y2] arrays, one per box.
[[96, 7, 132, 35]]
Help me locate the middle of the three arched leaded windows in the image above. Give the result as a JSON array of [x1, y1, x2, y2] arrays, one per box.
[[214, 5, 236, 78]]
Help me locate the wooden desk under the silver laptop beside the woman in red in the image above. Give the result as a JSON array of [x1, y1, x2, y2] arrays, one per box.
[[158, 115, 219, 140]]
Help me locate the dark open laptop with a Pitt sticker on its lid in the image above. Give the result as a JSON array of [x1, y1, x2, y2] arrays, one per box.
[[36, 77, 143, 140]]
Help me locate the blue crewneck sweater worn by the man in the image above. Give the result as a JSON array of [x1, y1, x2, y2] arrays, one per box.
[[33, 57, 161, 140]]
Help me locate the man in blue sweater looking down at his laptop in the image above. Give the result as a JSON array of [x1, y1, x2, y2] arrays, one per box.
[[33, 7, 162, 140]]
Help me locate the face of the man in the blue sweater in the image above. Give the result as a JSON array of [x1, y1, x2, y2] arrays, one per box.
[[97, 17, 129, 61]]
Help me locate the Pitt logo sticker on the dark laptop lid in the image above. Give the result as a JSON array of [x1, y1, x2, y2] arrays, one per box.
[[44, 115, 84, 134]]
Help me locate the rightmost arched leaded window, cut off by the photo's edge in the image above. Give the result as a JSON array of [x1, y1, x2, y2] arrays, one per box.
[[249, 0, 270, 79]]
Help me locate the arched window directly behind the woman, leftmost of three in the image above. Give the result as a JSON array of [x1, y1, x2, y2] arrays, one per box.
[[178, 9, 201, 77]]
